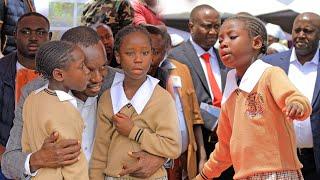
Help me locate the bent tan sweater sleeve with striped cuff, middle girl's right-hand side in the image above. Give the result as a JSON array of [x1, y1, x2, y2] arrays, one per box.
[[129, 92, 182, 159]]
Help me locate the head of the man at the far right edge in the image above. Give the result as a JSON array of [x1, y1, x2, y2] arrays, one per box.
[[292, 12, 320, 61]]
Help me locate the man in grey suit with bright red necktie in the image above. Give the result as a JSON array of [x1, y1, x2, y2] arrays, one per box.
[[169, 5, 232, 179]]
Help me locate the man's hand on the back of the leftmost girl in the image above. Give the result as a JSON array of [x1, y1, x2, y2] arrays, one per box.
[[30, 132, 81, 172]]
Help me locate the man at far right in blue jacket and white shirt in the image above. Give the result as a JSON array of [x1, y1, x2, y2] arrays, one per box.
[[263, 13, 320, 180]]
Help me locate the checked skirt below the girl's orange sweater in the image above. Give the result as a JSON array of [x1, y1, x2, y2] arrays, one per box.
[[241, 171, 303, 180]]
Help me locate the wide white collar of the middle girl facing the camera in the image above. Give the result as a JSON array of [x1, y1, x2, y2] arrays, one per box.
[[110, 73, 159, 114]]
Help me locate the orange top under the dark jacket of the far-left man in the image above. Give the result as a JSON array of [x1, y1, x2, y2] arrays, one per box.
[[15, 68, 38, 104]]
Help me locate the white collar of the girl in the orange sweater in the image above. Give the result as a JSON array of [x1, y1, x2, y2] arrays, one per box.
[[221, 59, 271, 104]]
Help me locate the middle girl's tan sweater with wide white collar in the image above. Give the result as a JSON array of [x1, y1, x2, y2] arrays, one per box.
[[89, 73, 181, 180]]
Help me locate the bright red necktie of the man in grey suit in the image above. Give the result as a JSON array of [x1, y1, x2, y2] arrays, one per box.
[[201, 53, 222, 107]]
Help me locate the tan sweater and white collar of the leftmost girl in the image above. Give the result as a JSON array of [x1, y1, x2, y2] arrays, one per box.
[[21, 87, 89, 180]]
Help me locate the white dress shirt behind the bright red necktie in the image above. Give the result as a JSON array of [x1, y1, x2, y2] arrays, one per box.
[[190, 37, 222, 99]]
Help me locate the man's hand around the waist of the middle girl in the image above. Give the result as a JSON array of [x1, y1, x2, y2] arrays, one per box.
[[119, 151, 166, 178]]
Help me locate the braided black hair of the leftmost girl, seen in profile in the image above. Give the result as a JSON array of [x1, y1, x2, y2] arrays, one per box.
[[36, 41, 77, 79]]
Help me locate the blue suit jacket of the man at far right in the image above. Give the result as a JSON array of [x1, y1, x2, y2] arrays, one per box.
[[262, 50, 320, 173]]
